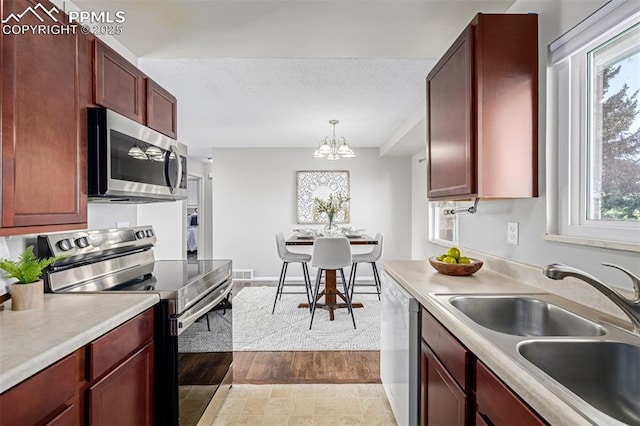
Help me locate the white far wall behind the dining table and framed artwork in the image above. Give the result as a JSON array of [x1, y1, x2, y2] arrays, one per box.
[[213, 145, 411, 277]]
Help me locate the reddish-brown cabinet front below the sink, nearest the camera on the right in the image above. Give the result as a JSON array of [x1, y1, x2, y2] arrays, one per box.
[[476, 361, 546, 426]]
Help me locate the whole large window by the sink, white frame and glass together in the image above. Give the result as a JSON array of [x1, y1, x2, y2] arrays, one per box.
[[547, 2, 640, 251]]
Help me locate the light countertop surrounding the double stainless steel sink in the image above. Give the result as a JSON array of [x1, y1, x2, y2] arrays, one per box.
[[382, 260, 608, 426]]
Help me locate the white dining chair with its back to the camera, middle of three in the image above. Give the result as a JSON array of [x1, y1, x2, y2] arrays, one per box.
[[309, 237, 356, 330]]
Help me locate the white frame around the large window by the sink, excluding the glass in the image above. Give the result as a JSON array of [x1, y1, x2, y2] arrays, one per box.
[[545, 0, 640, 252]]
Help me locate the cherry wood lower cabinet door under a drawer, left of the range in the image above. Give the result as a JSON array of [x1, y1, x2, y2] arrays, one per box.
[[87, 343, 153, 426]]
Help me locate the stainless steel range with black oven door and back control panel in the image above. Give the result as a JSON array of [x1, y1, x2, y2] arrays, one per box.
[[38, 226, 233, 425]]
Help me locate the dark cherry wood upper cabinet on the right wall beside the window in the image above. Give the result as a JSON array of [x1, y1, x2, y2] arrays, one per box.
[[427, 14, 538, 200]]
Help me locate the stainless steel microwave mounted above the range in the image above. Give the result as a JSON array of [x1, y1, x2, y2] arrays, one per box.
[[87, 108, 187, 203]]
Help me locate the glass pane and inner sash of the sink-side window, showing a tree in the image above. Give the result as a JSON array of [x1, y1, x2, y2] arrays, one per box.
[[586, 24, 640, 222]]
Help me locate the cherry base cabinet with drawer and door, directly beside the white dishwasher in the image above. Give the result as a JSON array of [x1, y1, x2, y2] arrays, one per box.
[[420, 309, 474, 425]]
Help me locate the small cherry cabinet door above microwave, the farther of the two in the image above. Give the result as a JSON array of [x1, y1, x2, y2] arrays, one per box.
[[147, 78, 178, 139]]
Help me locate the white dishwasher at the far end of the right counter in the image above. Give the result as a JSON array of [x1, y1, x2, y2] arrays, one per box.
[[380, 271, 420, 426]]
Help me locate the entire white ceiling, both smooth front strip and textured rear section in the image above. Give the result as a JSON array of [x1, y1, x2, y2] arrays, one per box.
[[74, 0, 515, 155]]
